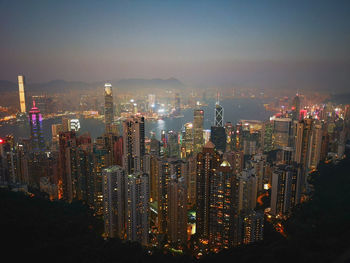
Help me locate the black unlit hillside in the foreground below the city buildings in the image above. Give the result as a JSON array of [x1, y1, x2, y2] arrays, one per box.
[[0, 154, 350, 262]]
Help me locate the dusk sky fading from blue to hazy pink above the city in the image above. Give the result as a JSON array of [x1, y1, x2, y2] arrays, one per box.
[[0, 0, 350, 90]]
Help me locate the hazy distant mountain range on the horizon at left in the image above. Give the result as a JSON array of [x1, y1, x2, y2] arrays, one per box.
[[0, 78, 186, 93]]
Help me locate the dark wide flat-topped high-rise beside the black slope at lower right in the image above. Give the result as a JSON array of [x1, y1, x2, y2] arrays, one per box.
[[271, 165, 301, 216]]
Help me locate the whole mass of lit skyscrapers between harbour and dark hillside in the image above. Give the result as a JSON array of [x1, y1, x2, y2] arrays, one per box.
[[0, 78, 350, 255]]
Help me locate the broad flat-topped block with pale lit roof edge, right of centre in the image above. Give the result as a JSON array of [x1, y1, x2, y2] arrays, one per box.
[[272, 118, 292, 149]]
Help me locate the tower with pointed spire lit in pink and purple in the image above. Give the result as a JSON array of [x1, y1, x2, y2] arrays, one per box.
[[29, 101, 45, 152]]
